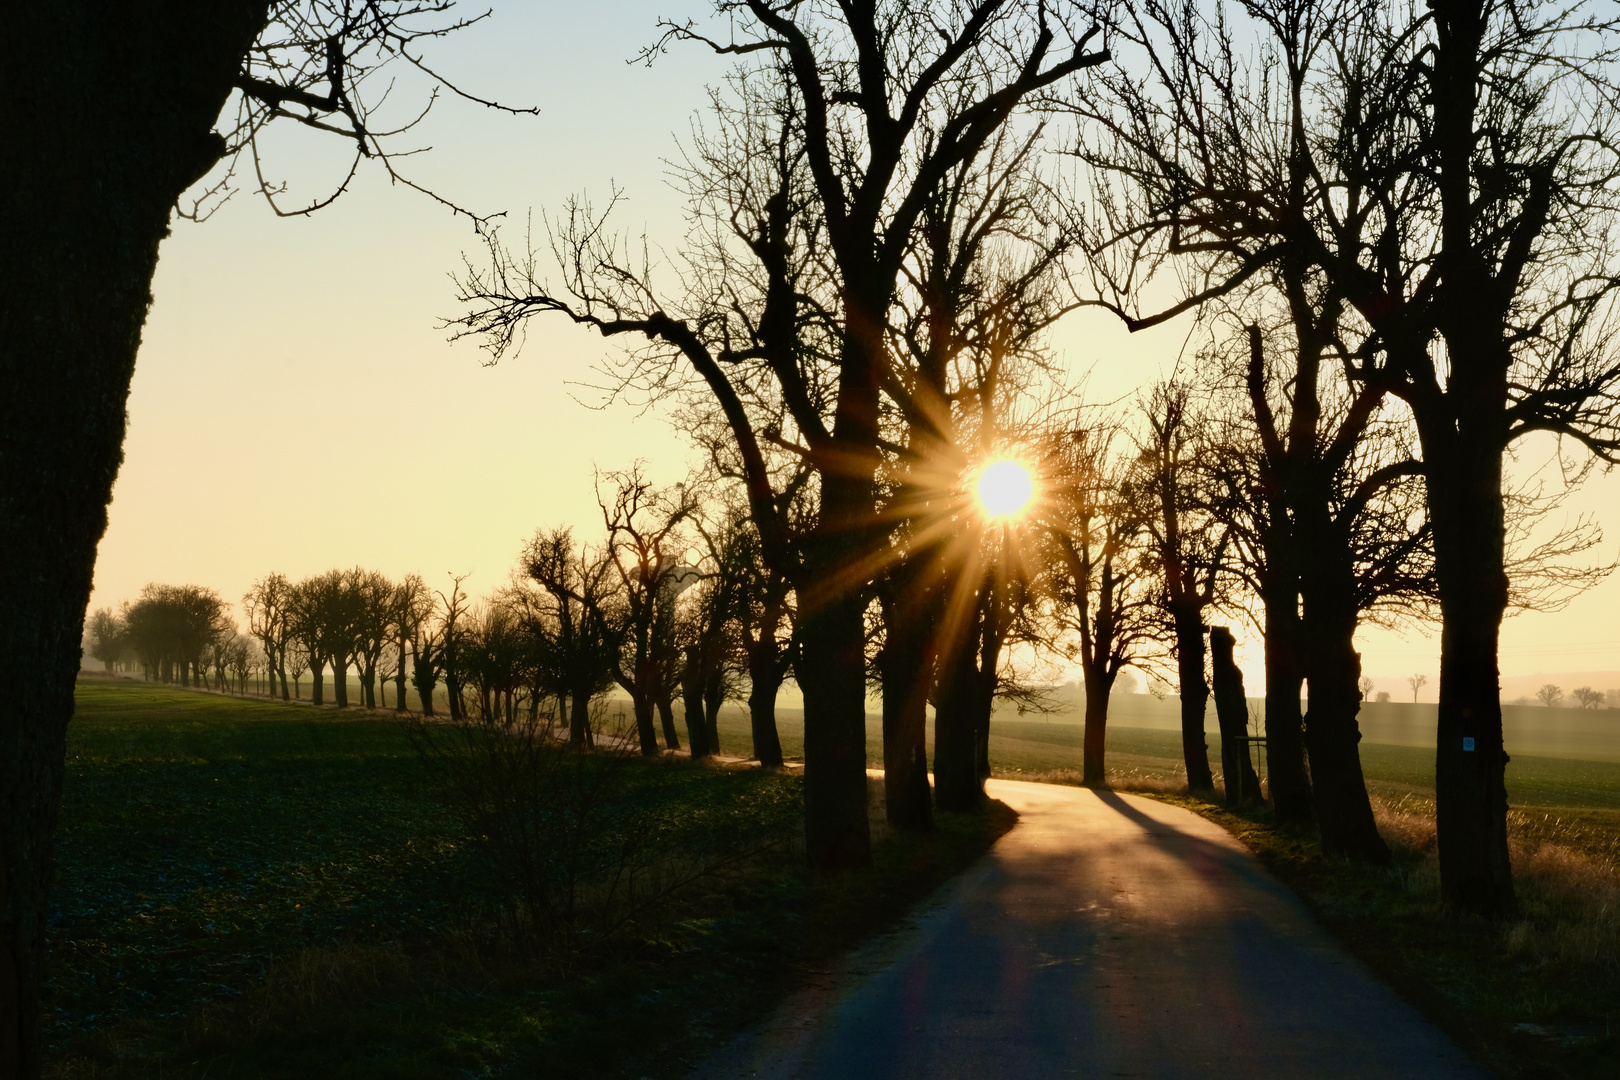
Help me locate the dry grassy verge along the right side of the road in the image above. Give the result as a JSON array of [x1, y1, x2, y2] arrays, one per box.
[[1121, 784, 1620, 1080]]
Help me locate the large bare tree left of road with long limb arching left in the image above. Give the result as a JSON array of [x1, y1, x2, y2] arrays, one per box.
[[463, 0, 1106, 873]]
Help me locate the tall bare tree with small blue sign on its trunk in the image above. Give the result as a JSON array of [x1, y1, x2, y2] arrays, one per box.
[[1092, 0, 1620, 916]]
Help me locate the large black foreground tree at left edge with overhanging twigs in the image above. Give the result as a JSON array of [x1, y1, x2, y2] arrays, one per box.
[[0, 10, 524, 1077]]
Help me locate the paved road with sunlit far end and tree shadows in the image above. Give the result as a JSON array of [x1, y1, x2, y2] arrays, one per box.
[[693, 780, 1486, 1080]]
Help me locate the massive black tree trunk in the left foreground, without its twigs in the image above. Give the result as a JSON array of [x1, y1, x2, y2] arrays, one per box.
[[0, 8, 264, 1078]]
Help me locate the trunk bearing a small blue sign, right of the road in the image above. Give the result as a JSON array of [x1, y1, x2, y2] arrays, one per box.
[[1432, 0, 1516, 918]]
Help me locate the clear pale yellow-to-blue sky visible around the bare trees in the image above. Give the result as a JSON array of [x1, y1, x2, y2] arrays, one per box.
[[91, 0, 1620, 699]]
